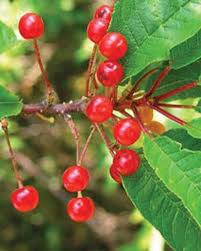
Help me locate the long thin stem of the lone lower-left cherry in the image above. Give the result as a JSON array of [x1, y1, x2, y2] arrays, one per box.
[[1, 119, 23, 188]]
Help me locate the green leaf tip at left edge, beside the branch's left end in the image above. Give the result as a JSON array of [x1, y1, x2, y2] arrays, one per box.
[[0, 86, 22, 119]]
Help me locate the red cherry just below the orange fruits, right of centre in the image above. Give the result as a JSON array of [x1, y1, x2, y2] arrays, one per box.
[[114, 118, 141, 146]]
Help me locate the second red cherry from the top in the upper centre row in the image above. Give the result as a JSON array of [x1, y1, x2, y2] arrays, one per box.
[[87, 18, 109, 44]]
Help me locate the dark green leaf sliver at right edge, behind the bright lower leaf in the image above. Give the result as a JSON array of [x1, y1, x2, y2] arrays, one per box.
[[164, 128, 201, 151]]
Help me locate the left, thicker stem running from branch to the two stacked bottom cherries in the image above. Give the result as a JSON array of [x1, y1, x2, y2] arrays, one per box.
[[64, 114, 80, 165]]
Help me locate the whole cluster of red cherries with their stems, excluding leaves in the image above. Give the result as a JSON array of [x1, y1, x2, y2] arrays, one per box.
[[0, 2, 197, 222]]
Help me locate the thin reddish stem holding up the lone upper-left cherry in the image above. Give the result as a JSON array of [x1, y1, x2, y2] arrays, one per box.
[[33, 39, 54, 95]]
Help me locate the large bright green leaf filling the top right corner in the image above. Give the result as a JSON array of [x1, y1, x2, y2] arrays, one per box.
[[110, 0, 201, 78]]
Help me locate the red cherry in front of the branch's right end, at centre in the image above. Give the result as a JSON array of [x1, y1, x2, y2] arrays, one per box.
[[86, 95, 113, 123]]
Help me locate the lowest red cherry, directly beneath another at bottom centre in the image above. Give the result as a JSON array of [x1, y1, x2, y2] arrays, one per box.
[[67, 197, 95, 222]]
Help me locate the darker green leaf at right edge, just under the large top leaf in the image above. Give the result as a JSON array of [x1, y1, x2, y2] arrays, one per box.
[[170, 30, 201, 69]]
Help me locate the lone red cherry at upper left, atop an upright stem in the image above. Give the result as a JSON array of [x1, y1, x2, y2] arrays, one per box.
[[18, 13, 44, 39]]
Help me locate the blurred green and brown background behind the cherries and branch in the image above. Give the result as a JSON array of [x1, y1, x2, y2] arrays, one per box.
[[0, 0, 185, 251]]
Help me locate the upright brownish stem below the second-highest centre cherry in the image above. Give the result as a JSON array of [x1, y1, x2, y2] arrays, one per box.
[[85, 44, 98, 97]]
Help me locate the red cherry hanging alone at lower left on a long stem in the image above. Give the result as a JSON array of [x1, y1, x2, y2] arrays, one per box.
[[11, 186, 39, 213]]
